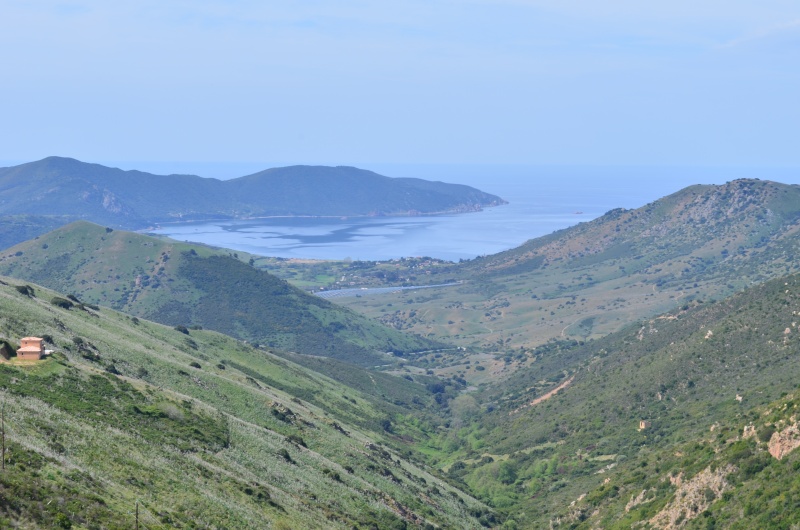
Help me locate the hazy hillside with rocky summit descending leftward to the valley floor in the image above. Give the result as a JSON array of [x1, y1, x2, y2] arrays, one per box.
[[337, 180, 800, 351]]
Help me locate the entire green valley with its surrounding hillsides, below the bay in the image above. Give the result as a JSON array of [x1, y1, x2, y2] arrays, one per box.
[[0, 171, 800, 530]]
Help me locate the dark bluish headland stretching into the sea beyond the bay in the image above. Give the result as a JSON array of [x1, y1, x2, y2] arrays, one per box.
[[0, 157, 504, 229]]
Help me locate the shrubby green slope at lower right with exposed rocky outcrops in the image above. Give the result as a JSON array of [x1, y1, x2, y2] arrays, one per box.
[[437, 275, 800, 528]]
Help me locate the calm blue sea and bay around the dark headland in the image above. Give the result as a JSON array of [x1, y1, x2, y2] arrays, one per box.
[[145, 163, 800, 261]]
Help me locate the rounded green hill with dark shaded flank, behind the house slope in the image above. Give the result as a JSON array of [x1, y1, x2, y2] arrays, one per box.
[[0, 221, 440, 366]]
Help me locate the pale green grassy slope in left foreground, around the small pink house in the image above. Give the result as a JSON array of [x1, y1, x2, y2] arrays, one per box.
[[0, 278, 487, 528]]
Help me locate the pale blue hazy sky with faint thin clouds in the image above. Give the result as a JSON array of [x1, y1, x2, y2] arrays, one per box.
[[0, 0, 800, 167]]
